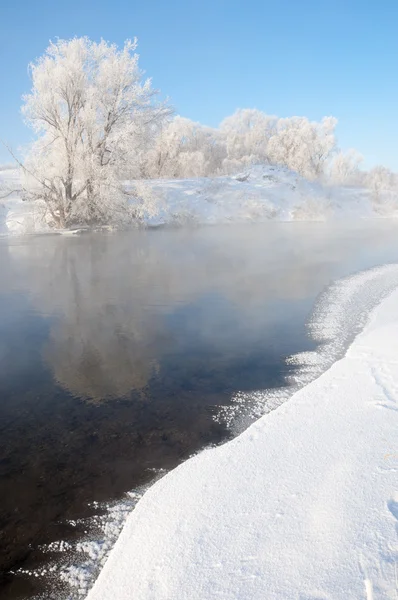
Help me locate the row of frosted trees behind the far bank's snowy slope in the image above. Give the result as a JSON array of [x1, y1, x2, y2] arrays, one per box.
[[132, 109, 346, 179]]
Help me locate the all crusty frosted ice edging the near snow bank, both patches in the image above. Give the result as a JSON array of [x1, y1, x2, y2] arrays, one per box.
[[37, 265, 398, 600]]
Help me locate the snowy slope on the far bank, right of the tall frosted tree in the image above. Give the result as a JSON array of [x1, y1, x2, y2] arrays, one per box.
[[146, 166, 382, 224]]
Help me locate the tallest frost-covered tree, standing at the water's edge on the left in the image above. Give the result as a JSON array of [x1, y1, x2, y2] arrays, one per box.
[[22, 37, 169, 227]]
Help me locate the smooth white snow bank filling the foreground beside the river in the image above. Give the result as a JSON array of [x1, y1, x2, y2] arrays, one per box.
[[88, 267, 398, 600]]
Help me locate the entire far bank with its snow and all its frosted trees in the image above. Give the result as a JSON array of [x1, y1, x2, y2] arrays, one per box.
[[0, 37, 398, 233]]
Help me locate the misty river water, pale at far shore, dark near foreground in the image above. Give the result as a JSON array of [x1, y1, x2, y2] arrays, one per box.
[[0, 223, 398, 600]]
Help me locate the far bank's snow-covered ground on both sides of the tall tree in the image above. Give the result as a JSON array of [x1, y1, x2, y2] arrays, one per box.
[[0, 166, 398, 234]]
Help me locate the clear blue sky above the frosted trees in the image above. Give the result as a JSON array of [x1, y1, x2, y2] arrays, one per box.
[[0, 0, 398, 170]]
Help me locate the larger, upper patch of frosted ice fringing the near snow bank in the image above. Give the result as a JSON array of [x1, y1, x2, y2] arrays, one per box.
[[224, 264, 398, 433]]
